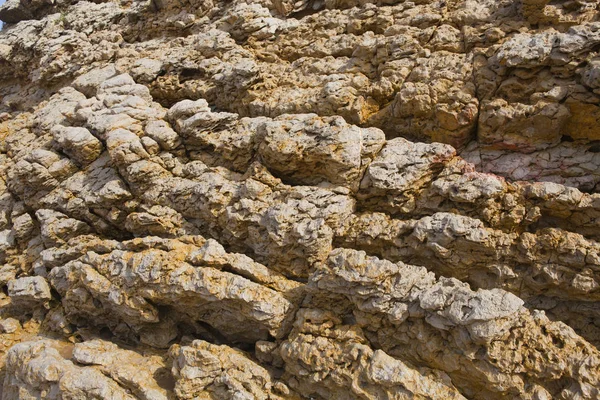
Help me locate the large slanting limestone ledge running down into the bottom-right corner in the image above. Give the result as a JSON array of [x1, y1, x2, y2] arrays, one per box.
[[311, 249, 600, 398]]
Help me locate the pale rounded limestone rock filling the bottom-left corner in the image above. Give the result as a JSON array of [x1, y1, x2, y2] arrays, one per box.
[[2, 339, 168, 400]]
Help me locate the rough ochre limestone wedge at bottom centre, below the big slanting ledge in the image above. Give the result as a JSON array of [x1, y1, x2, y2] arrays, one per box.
[[279, 309, 464, 399]]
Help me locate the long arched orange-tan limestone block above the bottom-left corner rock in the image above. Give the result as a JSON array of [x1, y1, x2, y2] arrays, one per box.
[[49, 237, 298, 346]]
